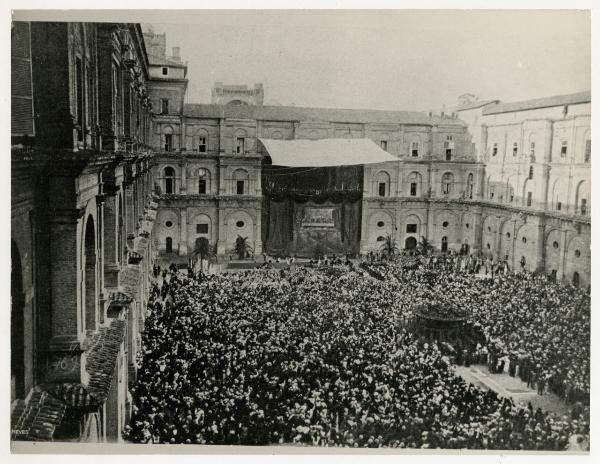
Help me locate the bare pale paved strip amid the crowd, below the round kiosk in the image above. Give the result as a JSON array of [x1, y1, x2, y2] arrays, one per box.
[[455, 365, 570, 414]]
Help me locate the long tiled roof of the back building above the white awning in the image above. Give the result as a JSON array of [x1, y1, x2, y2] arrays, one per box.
[[183, 104, 465, 126]]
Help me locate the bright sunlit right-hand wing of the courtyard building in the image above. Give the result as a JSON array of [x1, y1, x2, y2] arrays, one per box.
[[457, 92, 591, 286]]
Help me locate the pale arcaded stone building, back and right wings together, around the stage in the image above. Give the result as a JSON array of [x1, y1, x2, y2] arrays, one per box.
[[149, 36, 591, 286]]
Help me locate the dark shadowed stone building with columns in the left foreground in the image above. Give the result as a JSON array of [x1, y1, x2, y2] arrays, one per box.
[[11, 22, 156, 441]]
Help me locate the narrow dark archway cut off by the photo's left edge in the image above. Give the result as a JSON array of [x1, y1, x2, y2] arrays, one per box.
[[10, 240, 25, 402]]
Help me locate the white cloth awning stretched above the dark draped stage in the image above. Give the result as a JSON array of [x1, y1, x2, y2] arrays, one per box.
[[259, 139, 398, 167]]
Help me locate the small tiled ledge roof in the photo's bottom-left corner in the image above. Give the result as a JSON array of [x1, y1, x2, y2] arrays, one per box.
[[11, 387, 66, 441]]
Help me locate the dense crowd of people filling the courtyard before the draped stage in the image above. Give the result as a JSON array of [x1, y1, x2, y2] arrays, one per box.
[[126, 258, 589, 450]]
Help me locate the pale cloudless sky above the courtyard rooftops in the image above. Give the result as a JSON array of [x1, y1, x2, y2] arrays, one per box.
[[146, 10, 591, 110]]
